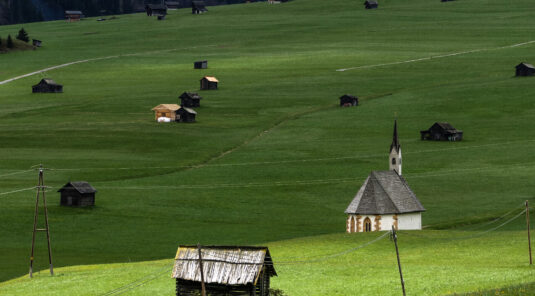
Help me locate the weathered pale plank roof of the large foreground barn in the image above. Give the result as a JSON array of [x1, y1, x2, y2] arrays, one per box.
[[172, 246, 277, 285]]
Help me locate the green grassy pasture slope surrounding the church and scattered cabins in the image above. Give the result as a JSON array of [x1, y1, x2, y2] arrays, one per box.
[[0, 0, 535, 296]]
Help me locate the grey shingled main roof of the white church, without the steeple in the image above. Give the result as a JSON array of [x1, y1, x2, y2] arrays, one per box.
[[345, 171, 425, 215]]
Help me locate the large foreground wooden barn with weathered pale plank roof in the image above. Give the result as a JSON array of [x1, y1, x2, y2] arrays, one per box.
[[172, 246, 277, 296]]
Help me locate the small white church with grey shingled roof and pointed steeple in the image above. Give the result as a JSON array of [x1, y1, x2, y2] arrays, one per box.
[[345, 122, 425, 233]]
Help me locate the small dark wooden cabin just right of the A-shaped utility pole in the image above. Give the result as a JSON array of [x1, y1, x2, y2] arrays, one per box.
[[58, 181, 97, 207]]
